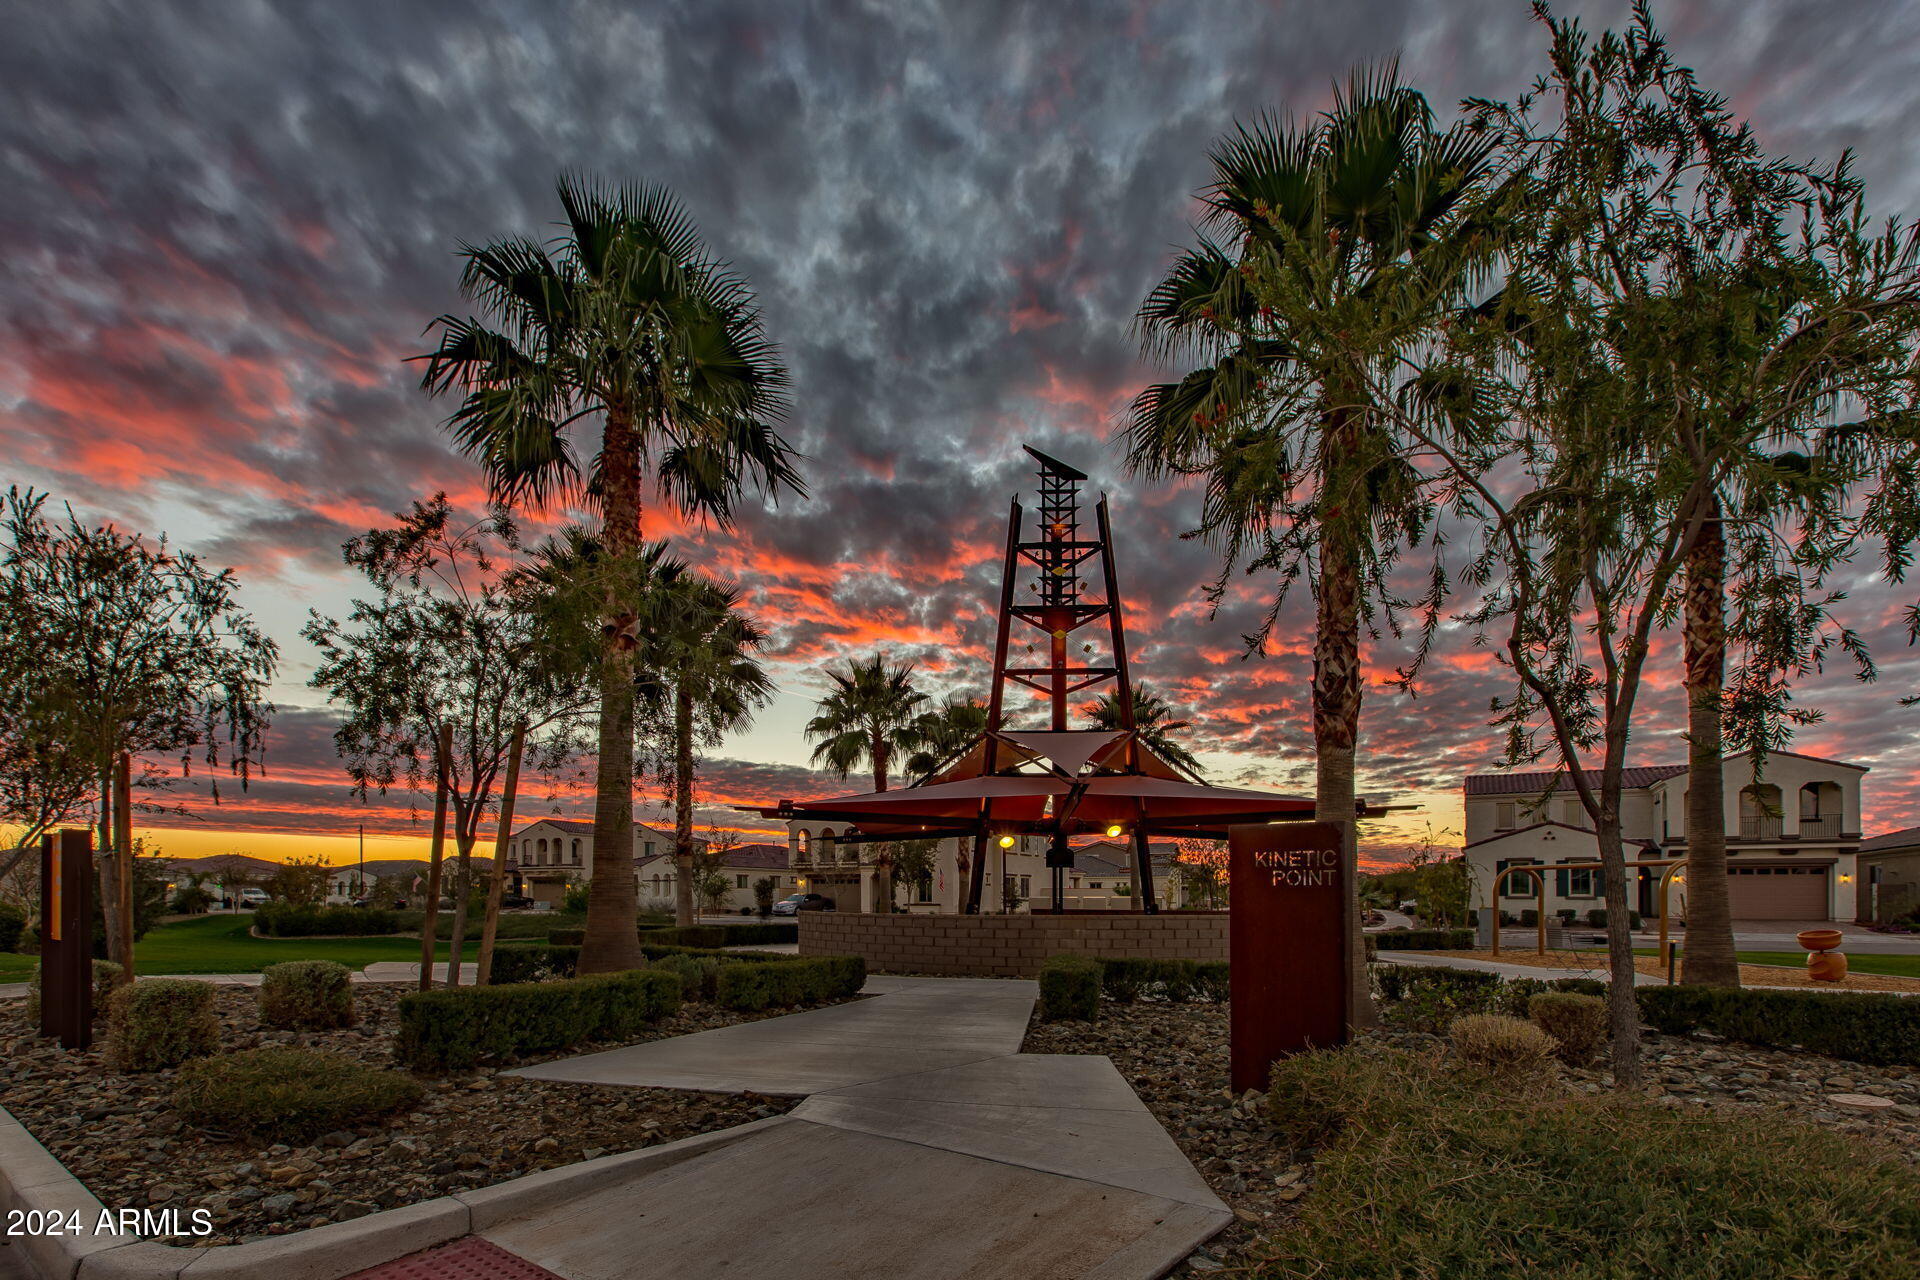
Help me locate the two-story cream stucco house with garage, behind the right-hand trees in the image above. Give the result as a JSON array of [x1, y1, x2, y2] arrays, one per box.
[[1465, 752, 1866, 921]]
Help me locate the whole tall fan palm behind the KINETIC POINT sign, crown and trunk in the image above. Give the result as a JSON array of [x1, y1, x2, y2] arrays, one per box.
[[1125, 63, 1496, 1021]]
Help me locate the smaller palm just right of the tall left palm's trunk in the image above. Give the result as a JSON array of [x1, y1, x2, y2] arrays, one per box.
[[639, 576, 774, 925]]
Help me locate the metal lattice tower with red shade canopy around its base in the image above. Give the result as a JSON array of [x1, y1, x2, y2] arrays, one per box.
[[758, 447, 1351, 913]]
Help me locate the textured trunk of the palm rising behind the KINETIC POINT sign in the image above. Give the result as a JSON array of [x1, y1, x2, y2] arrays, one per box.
[[1313, 413, 1377, 1029]]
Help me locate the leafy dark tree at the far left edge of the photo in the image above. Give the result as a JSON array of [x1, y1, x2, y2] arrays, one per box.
[[0, 487, 278, 961]]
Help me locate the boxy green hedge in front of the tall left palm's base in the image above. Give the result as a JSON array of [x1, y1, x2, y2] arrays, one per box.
[[394, 971, 680, 1071]]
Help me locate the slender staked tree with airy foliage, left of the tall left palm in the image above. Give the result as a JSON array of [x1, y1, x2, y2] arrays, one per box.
[[301, 493, 595, 975]]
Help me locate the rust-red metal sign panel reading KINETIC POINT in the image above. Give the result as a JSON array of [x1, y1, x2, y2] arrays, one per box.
[[1227, 821, 1352, 1094]]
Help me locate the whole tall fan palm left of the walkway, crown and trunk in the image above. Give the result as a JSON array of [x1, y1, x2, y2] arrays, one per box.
[[415, 178, 801, 973]]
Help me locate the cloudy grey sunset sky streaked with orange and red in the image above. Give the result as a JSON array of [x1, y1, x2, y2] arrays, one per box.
[[0, 0, 1920, 862]]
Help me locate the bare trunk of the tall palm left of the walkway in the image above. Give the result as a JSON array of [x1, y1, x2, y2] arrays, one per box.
[[578, 407, 645, 973]]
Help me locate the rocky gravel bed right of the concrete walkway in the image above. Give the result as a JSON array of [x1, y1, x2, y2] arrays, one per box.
[[1023, 1000, 1920, 1274]]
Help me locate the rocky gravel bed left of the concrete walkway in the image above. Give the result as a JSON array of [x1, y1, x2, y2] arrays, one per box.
[[0, 984, 833, 1245]]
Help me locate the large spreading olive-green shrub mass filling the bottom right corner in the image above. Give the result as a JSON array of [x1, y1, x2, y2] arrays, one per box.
[[1265, 1048, 1920, 1280]]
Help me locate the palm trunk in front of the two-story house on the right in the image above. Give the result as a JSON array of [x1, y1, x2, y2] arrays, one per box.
[[1682, 503, 1740, 986]]
